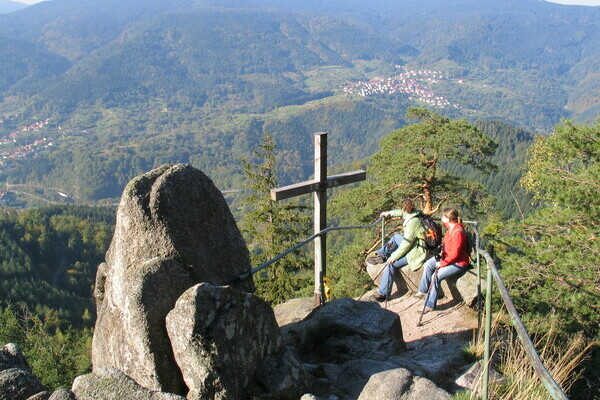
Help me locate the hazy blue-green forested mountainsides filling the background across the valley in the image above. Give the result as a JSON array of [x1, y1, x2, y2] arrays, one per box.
[[0, 0, 600, 208]]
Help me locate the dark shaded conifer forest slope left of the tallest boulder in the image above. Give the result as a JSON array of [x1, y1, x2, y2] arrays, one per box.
[[0, 206, 114, 327]]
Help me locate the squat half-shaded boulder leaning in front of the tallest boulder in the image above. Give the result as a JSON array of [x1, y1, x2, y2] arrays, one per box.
[[167, 283, 306, 400]]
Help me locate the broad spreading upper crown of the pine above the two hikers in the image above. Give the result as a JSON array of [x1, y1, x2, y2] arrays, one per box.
[[335, 108, 496, 222]]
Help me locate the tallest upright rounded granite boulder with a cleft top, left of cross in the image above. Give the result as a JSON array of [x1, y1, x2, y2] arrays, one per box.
[[92, 164, 254, 394]]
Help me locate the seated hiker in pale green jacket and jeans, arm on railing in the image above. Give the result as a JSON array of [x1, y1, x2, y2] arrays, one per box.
[[368, 199, 427, 301]]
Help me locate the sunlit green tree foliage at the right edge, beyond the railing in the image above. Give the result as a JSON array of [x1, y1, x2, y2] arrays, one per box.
[[497, 121, 600, 339]]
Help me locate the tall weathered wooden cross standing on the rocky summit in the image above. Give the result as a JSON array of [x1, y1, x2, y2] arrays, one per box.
[[271, 132, 367, 307]]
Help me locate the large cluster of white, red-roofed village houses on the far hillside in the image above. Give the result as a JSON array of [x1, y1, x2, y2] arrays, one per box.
[[342, 65, 460, 109]]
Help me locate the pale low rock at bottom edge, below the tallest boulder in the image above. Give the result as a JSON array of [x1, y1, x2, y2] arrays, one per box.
[[71, 368, 184, 400]]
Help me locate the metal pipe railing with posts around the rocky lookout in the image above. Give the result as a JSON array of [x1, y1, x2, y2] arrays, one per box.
[[238, 218, 568, 400]]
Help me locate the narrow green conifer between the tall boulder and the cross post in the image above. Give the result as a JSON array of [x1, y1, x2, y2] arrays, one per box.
[[240, 134, 310, 304]]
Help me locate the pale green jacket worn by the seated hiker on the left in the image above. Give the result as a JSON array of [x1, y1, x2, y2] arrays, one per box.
[[389, 210, 427, 271]]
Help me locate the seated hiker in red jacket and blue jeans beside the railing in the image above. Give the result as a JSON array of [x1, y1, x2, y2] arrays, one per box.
[[415, 208, 469, 312]]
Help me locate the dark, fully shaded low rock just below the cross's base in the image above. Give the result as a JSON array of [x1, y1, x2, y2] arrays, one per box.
[[282, 298, 406, 363]]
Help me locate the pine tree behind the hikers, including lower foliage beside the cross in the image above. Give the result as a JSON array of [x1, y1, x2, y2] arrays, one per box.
[[328, 108, 496, 295]]
